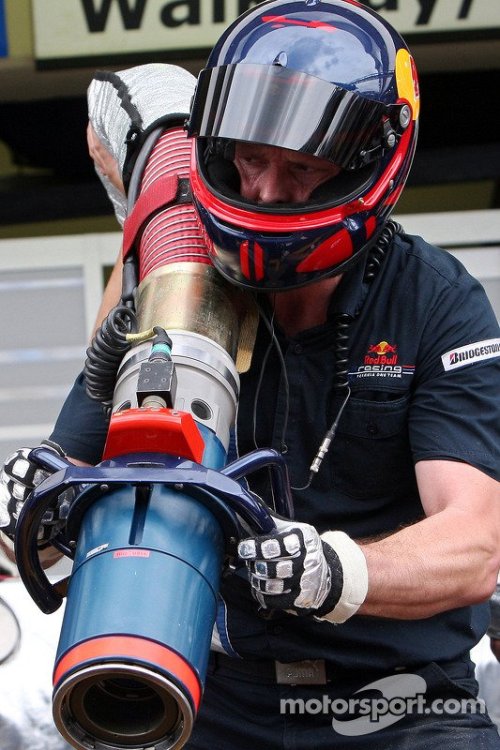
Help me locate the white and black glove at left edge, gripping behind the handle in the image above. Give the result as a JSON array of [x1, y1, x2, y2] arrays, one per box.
[[0, 440, 72, 549]]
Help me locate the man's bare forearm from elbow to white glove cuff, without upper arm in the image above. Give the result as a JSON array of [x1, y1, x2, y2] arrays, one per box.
[[359, 508, 499, 620]]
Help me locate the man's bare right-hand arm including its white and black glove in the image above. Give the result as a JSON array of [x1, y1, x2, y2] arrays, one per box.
[[238, 460, 500, 624]]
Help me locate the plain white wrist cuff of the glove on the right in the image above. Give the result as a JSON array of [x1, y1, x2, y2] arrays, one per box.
[[317, 531, 368, 624]]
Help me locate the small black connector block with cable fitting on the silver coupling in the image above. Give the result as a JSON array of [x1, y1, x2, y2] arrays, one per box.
[[137, 326, 177, 409]]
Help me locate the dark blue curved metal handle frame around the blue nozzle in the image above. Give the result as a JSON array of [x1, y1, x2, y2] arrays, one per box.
[[15, 447, 285, 614]]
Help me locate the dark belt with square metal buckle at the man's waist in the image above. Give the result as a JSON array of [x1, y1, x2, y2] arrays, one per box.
[[209, 651, 392, 685]]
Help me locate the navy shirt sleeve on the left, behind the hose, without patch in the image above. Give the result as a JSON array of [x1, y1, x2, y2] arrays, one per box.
[[50, 373, 109, 464]]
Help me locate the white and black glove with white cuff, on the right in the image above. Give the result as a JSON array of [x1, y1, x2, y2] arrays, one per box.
[[238, 516, 368, 623]]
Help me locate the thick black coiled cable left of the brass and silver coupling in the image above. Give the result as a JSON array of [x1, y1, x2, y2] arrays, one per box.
[[83, 305, 137, 414]]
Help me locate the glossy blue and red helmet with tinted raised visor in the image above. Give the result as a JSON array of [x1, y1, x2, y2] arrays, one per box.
[[187, 0, 419, 291]]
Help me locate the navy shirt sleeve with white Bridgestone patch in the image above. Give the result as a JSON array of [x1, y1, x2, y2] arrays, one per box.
[[410, 270, 500, 479]]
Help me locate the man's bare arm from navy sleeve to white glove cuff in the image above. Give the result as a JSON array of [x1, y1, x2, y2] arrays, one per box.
[[359, 460, 500, 620]]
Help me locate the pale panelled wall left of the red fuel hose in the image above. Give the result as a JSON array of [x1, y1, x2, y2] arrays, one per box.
[[0, 233, 120, 461]]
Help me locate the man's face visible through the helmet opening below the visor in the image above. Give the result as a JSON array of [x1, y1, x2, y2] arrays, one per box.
[[234, 142, 341, 204]]
